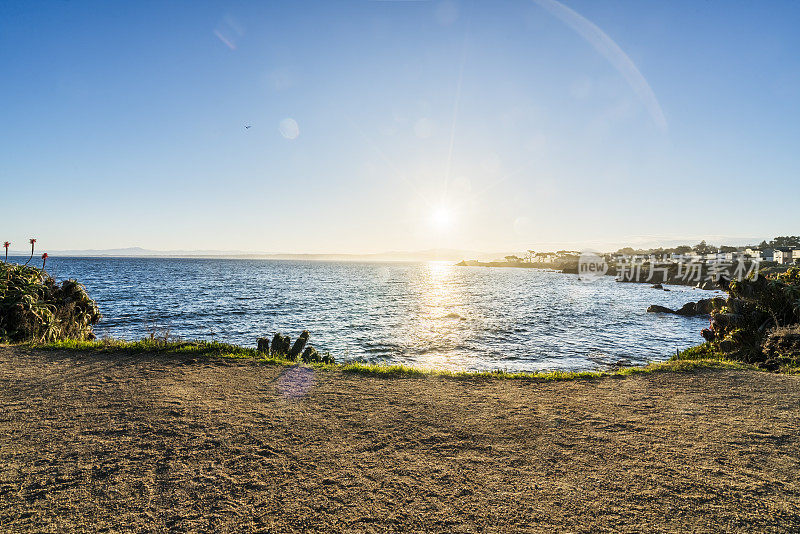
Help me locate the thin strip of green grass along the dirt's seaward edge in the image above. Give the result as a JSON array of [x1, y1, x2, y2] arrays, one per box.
[[20, 339, 768, 382]]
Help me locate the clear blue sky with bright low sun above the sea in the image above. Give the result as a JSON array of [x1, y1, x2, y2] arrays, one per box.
[[0, 0, 800, 253]]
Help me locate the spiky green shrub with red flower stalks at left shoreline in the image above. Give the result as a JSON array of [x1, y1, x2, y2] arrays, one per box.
[[0, 263, 100, 342]]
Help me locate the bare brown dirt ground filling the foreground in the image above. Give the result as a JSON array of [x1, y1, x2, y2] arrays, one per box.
[[0, 347, 800, 532]]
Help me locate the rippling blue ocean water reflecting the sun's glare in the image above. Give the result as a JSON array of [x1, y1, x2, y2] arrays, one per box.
[[18, 258, 718, 371]]
